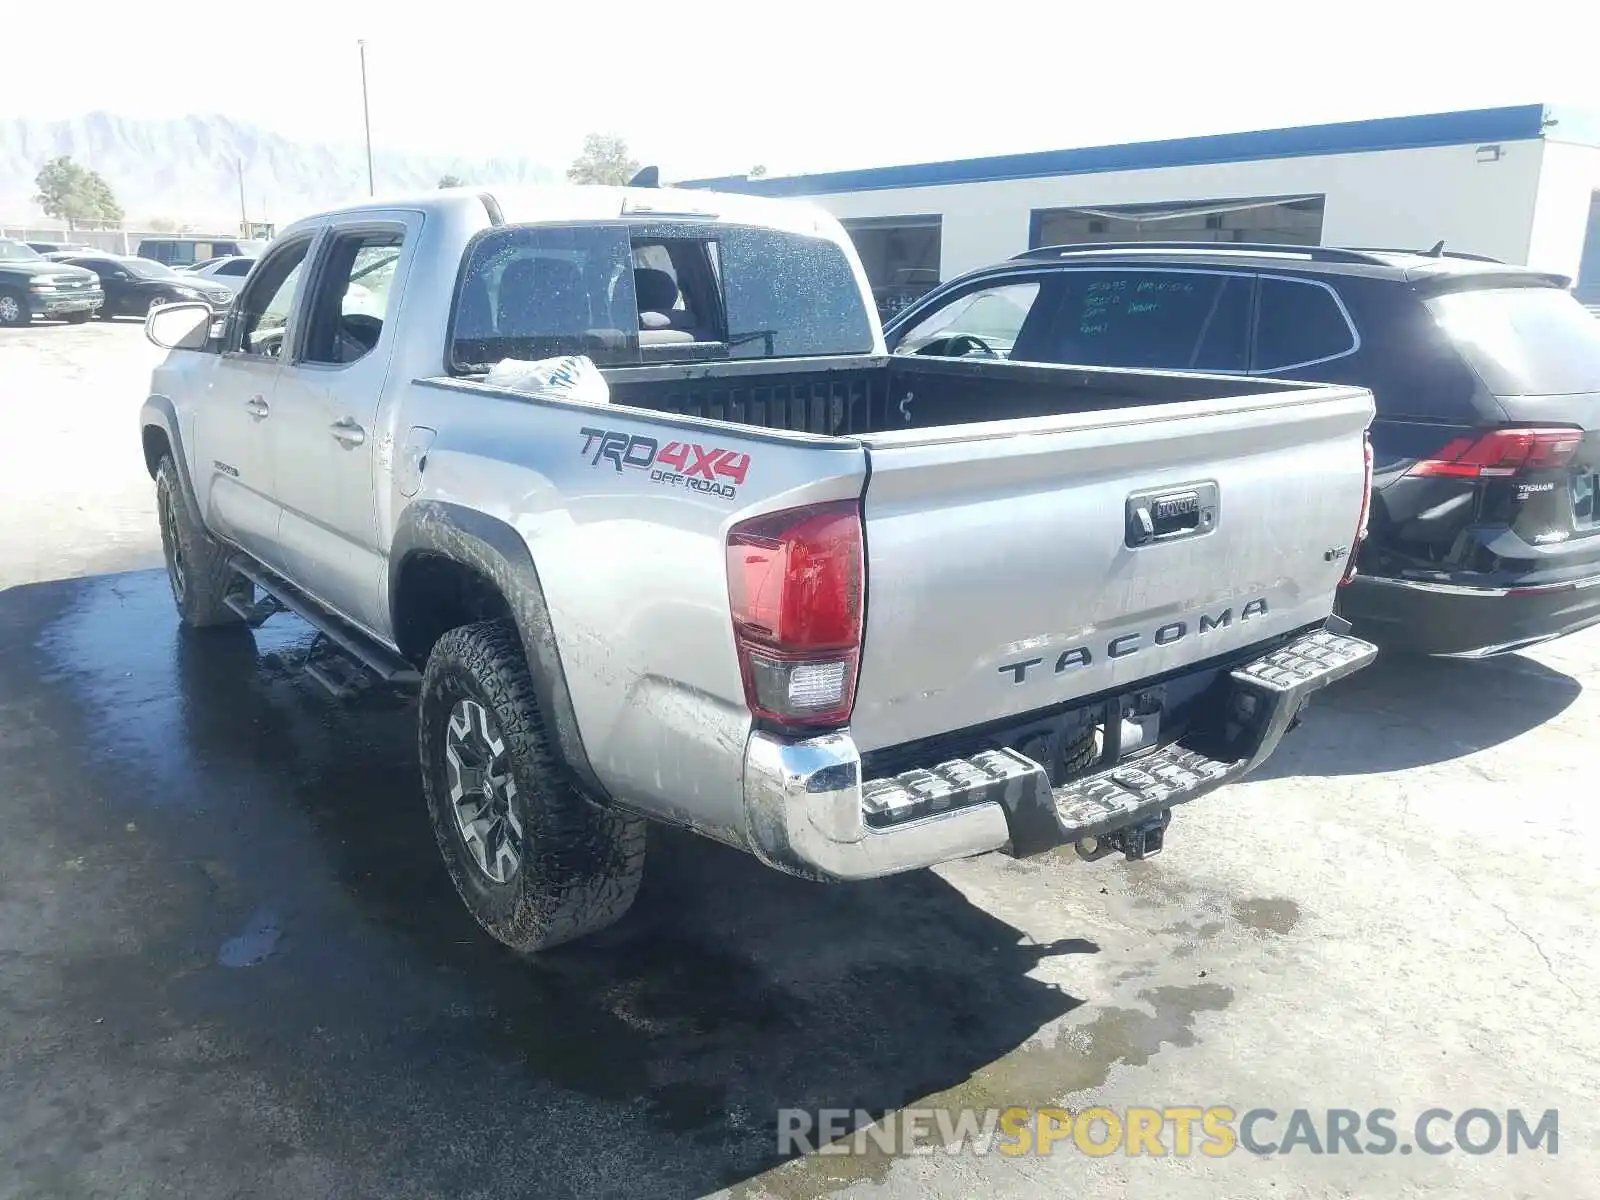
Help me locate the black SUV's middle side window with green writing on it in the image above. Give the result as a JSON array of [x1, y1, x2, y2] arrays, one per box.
[[1038, 269, 1250, 371]]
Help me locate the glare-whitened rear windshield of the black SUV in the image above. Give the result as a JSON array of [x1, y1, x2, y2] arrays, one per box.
[[1427, 286, 1600, 395]]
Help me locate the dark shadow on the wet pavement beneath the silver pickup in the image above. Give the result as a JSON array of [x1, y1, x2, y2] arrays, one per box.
[[0, 573, 1098, 1197]]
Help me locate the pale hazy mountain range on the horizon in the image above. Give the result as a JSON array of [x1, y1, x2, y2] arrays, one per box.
[[0, 112, 560, 232]]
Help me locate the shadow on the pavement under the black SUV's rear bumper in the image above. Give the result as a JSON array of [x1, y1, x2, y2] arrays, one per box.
[[1251, 654, 1582, 779]]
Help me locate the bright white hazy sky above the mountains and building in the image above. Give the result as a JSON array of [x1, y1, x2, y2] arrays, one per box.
[[12, 0, 1600, 178]]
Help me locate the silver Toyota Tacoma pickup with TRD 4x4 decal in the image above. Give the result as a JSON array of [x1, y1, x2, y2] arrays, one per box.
[[141, 187, 1374, 949]]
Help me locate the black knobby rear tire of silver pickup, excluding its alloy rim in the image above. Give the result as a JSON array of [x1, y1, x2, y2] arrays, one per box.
[[418, 621, 645, 954]]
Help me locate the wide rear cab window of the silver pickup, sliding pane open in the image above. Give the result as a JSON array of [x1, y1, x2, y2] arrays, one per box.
[[450, 221, 874, 371]]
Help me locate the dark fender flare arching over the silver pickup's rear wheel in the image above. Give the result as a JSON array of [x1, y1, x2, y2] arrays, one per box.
[[389, 501, 610, 800]]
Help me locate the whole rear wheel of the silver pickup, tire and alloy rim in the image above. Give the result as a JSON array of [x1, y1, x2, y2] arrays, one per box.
[[418, 621, 645, 952]]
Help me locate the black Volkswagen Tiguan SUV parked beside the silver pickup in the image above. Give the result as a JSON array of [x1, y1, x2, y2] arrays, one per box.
[[885, 242, 1600, 658]]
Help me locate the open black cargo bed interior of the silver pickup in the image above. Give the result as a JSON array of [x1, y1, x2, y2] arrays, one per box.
[[602, 355, 1307, 437]]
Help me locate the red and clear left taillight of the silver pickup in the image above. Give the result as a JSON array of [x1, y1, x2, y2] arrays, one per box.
[[728, 501, 864, 725]]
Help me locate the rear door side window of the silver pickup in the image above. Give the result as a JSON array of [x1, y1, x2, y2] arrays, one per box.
[[302, 230, 405, 365]]
